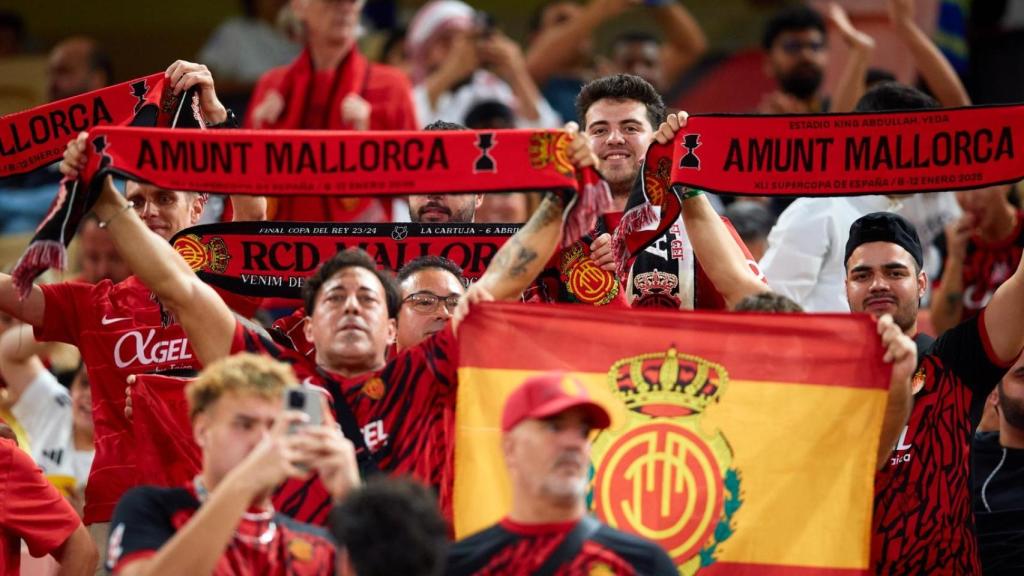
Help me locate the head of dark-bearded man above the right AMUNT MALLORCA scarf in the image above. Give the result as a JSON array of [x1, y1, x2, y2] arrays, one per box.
[[758, 5, 828, 114]]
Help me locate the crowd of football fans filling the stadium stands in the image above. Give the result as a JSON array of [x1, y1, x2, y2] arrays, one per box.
[[0, 0, 1024, 576]]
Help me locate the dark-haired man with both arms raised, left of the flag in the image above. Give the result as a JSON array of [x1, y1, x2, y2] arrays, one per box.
[[86, 124, 596, 523]]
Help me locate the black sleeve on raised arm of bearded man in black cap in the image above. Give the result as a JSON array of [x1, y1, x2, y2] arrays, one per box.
[[930, 311, 1012, 403]]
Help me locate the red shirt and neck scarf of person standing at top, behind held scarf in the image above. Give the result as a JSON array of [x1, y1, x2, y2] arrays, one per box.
[[245, 46, 403, 221]]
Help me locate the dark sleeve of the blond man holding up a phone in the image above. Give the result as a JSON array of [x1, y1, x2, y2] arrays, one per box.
[[106, 486, 199, 574]]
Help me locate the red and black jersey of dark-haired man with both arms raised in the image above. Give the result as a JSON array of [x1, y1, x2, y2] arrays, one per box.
[[231, 324, 459, 525]]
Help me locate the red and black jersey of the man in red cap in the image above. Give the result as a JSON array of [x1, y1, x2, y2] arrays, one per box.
[[444, 519, 679, 576]]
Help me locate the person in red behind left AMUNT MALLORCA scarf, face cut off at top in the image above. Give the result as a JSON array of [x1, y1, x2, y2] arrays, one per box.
[[245, 0, 418, 222]]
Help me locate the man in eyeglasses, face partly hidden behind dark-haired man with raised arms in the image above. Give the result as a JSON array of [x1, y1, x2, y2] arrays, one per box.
[[395, 255, 466, 352]]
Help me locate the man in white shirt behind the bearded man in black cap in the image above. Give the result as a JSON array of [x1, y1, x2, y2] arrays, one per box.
[[760, 82, 961, 312]]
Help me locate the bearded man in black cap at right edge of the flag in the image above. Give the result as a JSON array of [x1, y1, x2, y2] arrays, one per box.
[[846, 212, 1024, 574]]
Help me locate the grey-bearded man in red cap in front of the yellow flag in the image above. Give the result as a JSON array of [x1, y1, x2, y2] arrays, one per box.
[[445, 372, 679, 576]]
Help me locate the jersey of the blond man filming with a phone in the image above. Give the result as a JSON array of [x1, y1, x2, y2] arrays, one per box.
[[106, 484, 336, 576]]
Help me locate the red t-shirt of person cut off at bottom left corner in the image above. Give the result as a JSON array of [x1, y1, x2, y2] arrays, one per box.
[[0, 439, 82, 576]]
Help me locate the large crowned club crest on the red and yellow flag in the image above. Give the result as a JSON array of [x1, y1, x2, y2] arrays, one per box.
[[592, 347, 742, 576]]
